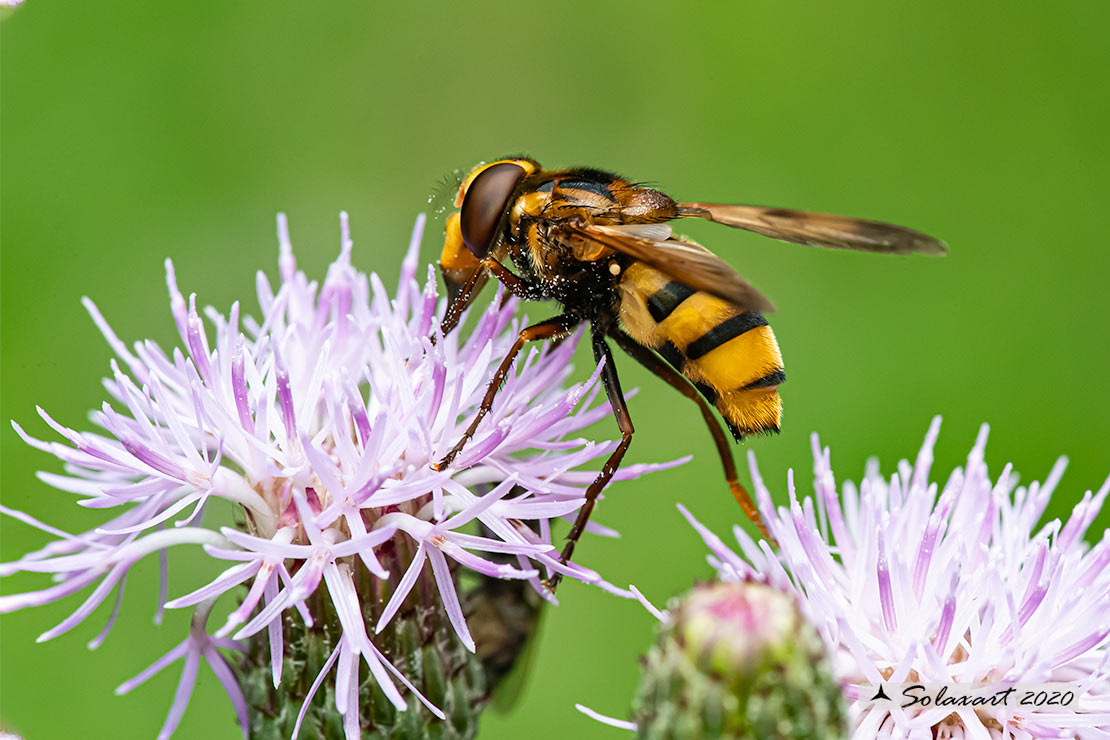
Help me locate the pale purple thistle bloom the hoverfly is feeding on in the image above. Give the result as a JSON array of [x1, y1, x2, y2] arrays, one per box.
[[0, 214, 670, 740]]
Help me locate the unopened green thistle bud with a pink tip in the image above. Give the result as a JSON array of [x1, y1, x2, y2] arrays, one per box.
[[632, 581, 847, 740]]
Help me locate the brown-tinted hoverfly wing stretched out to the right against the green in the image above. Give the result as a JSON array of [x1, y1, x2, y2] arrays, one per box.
[[678, 203, 948, 254]]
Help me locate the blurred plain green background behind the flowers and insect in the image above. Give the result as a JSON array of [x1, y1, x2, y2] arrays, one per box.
[[0, 0, 1110, 740]]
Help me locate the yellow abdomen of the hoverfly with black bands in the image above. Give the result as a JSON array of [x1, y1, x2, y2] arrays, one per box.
[[619, 262, 786, 439]]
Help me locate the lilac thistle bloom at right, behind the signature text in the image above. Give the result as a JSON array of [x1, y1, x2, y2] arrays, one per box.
[[680, 417, 1110, 740]]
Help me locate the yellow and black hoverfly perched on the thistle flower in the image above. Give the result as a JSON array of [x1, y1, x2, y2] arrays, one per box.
[[435, 158, 947, 588]]
